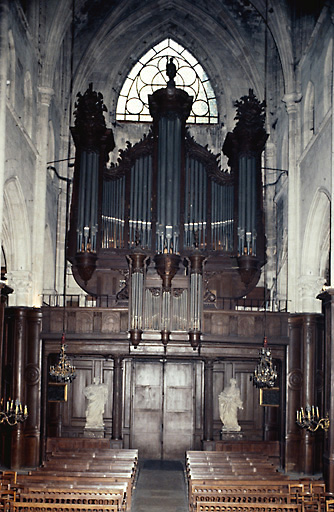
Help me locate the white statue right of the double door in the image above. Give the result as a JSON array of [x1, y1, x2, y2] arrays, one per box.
[[218, 379, 243, 432]]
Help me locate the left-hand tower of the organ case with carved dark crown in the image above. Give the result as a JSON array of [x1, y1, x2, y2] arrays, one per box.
[[68, 84, 115, 283]]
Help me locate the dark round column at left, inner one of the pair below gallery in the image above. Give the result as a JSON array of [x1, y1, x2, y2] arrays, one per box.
[[24, 308, 42, 467]]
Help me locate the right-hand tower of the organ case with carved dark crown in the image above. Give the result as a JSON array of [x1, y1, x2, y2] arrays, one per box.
[[223, 89, 268, 286]]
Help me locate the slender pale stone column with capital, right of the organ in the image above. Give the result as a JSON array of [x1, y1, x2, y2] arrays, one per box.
[[283, 93, 300, 313]]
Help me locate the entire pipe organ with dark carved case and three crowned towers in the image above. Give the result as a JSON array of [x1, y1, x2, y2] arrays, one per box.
[[68, 64, 267, 349]]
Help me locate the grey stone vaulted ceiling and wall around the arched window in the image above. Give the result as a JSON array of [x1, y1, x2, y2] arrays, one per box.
[[40, 0, 322, 135]]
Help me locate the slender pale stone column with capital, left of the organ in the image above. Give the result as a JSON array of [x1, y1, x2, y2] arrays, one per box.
[[32, 87, 54, 306]]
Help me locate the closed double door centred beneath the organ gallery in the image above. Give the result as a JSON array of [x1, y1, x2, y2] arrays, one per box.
[[131, 360, 198, 460]]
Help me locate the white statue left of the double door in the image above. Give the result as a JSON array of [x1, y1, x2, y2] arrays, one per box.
[[84, 377, 108, 429]]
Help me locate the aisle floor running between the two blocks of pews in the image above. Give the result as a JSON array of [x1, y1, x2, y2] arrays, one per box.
[[131, 460, 188, 512]]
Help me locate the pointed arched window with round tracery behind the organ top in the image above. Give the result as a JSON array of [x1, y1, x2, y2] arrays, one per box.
[[116, 38, 218, 124]]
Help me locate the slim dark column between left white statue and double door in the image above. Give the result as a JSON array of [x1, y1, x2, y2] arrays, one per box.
[[111, 357, 123, 448]]
